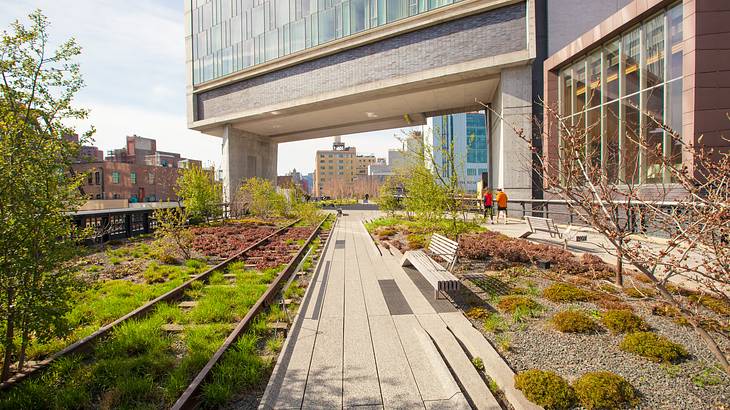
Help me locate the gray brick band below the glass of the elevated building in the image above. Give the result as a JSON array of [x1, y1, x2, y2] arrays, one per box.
[[196, 3, 527, 120]]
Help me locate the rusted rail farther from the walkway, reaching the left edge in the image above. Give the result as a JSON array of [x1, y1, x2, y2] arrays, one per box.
[[0, 219, 298, 391]]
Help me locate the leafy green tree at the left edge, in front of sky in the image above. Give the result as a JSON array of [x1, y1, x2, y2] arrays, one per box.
[[0, 11, 93, 380]]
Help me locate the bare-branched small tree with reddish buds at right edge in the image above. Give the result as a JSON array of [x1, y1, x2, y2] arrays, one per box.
[[484, 98, 730, 373]]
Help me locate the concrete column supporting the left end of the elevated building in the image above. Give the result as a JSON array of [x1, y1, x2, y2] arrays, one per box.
[[222, 125, 278, 201]]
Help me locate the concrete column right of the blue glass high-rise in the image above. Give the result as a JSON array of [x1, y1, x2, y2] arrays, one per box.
[[490, 66, 532, 199]]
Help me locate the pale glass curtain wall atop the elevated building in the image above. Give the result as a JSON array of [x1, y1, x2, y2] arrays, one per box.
[[189, 0, 461, 84]]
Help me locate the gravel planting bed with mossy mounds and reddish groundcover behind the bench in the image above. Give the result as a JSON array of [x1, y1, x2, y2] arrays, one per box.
[[454, 232, 730, 409]]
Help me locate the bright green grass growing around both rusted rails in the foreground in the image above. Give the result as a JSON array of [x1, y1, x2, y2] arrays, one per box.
[[0, 240, 292, 410]]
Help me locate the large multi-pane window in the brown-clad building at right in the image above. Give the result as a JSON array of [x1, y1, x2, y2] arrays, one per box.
[[558, 3, 683, 183]]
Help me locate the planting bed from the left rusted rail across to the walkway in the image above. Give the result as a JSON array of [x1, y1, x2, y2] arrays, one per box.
[[0, 218, 330, 409]]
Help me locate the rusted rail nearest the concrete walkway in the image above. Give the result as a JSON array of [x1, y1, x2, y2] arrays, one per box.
[[172, 215, 329, 410]]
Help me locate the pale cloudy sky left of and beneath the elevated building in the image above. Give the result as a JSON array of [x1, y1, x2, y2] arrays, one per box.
[[0, 0, 410, 175]]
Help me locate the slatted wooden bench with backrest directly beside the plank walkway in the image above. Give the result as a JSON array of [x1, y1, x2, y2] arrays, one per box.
[[401, 234, 459, 299]]
